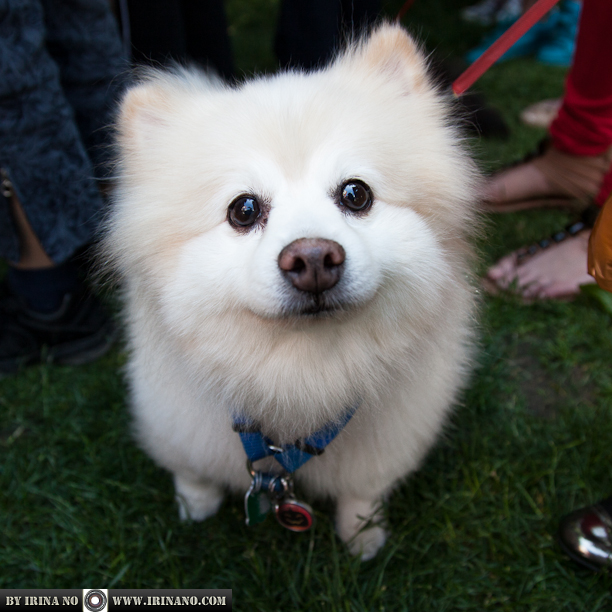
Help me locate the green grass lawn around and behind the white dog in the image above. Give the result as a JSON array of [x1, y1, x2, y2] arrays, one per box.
[[0, 0, 612, 612]]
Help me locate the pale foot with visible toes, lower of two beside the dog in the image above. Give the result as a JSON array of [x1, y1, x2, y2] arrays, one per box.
[[485, 230, 595, 301]]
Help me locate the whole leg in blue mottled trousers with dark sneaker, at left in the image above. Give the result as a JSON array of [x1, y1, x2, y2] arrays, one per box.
[[0, 0, 118, 374]]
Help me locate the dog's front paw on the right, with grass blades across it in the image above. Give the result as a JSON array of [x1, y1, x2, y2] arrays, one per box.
[[336, 497, 387, 561]]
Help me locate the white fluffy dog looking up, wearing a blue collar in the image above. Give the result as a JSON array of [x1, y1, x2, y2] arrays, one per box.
[[105, 25, 477, 559]]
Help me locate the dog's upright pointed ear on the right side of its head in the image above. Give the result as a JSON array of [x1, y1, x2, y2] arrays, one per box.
[[349, 23, 428, 93]]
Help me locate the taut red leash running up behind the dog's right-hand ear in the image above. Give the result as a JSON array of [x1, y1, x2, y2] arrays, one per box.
[[397, 0, 559, 96]]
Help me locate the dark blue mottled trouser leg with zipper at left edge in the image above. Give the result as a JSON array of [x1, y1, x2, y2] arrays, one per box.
[[0, 0, 102, 263]]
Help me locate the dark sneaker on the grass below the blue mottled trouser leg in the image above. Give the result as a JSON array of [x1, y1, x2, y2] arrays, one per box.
[[0, 284, 117, 376]]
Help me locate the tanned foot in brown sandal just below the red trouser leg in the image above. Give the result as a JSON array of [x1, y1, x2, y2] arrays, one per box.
[[483, 140, 612, 213]]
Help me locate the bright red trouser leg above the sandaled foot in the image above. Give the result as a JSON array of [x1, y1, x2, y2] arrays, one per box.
[[550, 0, 612, 204]]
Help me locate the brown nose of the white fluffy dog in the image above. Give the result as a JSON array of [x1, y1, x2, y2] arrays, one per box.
[[278, 238, 346, 293]]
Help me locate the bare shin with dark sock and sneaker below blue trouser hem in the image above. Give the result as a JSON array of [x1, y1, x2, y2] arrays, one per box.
[[0, 181, 115, 377]]
